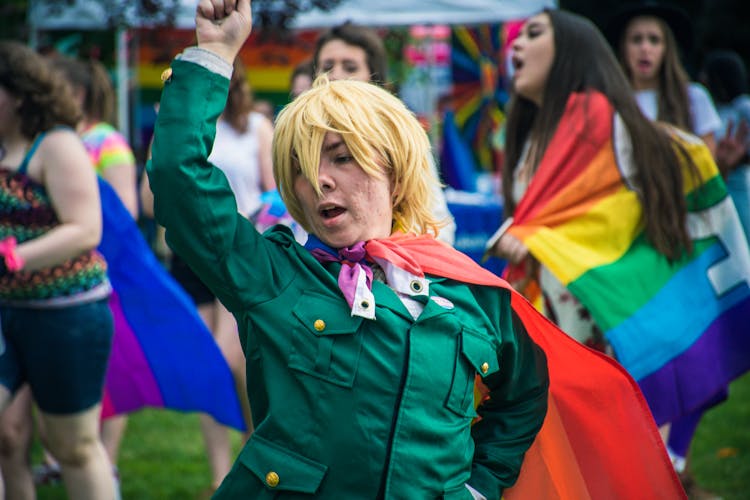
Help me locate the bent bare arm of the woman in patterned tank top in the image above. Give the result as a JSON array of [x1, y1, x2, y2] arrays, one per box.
[[17, 130, 102, 270]]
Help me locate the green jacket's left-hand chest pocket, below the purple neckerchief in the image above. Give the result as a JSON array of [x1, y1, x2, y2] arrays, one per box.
[[289, 292, 362, 387]]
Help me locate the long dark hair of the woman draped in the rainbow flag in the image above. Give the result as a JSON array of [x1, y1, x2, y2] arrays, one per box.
[[503, 10, 700, 259]]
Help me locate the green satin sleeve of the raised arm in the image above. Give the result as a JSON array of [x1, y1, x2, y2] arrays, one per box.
[[147, 55, 291, 311]]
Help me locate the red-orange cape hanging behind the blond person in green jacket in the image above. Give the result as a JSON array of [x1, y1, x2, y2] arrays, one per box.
[[366, 233, 686, 500]]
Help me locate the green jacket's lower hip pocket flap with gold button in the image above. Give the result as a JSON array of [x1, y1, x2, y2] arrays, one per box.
[[239, 434, 328, 494]]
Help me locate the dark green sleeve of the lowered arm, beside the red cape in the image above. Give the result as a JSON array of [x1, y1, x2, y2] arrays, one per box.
[[469, 289, 549, 500]]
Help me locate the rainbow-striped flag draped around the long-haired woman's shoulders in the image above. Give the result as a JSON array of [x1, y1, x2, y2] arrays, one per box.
[[509, 93, 750, 424]]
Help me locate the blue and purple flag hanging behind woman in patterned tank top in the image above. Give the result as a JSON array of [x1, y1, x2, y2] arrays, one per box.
[[99, 178, 246, 431]]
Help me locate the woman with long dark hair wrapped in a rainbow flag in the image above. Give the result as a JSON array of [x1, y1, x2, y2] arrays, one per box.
[[489, 11, 750, 498]]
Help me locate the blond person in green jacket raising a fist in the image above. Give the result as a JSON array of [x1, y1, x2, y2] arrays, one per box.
[[147, 0, 549, 500]]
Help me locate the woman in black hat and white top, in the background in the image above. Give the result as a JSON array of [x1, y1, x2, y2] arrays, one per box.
[[607, 2, 721, 153]]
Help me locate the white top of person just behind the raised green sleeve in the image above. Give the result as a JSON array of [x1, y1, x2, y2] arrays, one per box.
[[208, 112, 265, 217]]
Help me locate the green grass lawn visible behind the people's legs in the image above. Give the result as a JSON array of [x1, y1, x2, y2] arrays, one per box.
[[35, 374, 750, 500]]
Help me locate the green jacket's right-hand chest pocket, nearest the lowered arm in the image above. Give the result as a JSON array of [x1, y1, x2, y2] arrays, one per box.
[[445, 327, 500, 418]]
